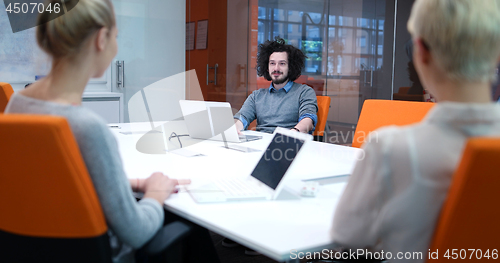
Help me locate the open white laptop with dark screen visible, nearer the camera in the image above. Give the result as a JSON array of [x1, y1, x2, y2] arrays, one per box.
[[186, 128, 312, 203]]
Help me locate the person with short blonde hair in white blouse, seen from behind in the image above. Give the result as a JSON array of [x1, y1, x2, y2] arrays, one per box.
[[331, 0, 500, 262]]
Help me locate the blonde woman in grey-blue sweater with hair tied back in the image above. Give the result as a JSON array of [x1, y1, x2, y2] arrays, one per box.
[[6, 0, 219, 262]]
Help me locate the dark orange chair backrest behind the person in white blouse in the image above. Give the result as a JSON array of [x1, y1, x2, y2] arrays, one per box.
[[430, 138, 500, 261]]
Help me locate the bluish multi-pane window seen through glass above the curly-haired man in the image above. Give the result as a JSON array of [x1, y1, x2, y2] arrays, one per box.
[[258, 0, 385, 75]]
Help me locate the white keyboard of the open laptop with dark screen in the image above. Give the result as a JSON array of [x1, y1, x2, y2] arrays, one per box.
[[214, 178, 265, 197]]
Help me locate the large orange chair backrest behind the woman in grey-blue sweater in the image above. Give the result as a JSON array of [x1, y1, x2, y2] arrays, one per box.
[[0, 114, 111, 262]]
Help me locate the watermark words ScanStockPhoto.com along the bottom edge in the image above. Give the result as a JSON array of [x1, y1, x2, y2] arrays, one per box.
[[290, 249, 424, 260]]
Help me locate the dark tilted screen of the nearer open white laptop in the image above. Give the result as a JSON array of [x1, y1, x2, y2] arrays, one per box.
[[252, 133, 304, 189]]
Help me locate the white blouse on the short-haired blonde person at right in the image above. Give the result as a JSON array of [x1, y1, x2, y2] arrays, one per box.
[[330, 102, 500, 262]]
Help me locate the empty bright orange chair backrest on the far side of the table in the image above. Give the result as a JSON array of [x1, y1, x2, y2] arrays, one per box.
[[352, 100, 434, 148]]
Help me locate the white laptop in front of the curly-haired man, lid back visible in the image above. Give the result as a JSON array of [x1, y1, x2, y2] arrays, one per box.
[[179, 100, 262, 142]]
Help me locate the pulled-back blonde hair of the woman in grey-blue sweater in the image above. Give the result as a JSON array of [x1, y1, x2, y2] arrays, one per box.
[[36, 0, 115, 59]]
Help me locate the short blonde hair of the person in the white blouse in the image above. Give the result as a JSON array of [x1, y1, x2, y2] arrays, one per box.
[[408, 0, 500, 82]]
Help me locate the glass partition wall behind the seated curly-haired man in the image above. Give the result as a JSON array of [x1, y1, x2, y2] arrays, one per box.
[[197, 0, 396, 144]]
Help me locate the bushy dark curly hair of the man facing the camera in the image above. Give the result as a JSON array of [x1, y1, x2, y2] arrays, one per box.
[[257, 36, 307, 81]]
